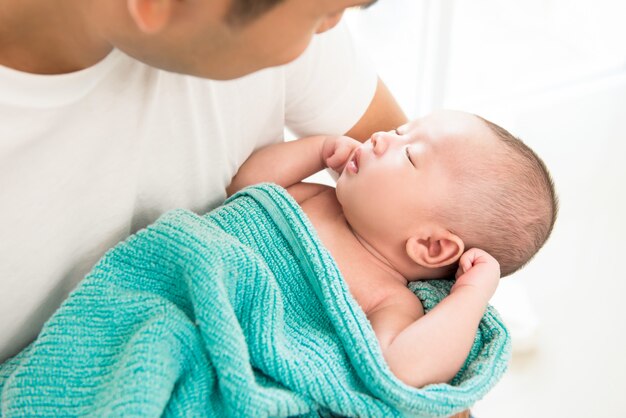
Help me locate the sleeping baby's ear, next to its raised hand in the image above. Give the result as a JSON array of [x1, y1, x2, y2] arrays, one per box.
[[406, 230, 465, 268]]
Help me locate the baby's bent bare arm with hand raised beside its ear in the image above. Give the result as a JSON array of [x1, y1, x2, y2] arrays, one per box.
[[369, 248, 500, 387]]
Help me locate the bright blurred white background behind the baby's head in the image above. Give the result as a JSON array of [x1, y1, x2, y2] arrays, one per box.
[[347, 0, 626, 418]]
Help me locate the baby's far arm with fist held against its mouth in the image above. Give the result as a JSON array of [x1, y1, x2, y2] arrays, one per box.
[[226, 135, 361, 196]]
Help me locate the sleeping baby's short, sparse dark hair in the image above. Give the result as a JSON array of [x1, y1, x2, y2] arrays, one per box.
[[444, 116, 559, 277]]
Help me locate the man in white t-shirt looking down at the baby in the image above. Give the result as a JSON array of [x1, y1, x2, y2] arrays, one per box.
[[0, 0, 406, 362]]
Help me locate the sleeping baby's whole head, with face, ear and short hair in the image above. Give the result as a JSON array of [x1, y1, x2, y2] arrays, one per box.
[[337, 111, 558, 278]]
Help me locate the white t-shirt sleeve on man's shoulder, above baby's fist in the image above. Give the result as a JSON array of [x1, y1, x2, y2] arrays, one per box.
[[285, 22, 377, 136]]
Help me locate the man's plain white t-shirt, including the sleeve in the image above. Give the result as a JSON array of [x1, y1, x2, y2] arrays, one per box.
[[0, 25, 376, 362]]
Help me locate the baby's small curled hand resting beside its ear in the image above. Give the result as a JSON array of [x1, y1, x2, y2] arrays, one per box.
[[450, 248, 500, 302]]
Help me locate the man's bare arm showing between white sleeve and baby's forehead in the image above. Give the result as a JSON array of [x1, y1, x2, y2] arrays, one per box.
[[345, 78, 407, 142]]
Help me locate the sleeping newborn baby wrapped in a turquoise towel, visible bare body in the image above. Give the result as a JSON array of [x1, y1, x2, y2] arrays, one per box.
[[228, 111, 557, 387]]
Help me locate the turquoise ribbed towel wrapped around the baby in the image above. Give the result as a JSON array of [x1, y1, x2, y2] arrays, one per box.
[[0, 184, 510, 417]]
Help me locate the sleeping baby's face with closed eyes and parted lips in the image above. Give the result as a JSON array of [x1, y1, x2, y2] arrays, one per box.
[[337, 111, 495, 250]]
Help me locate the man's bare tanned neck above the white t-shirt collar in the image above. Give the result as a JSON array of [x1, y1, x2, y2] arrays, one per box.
[[0, 0, 112, 74]]
